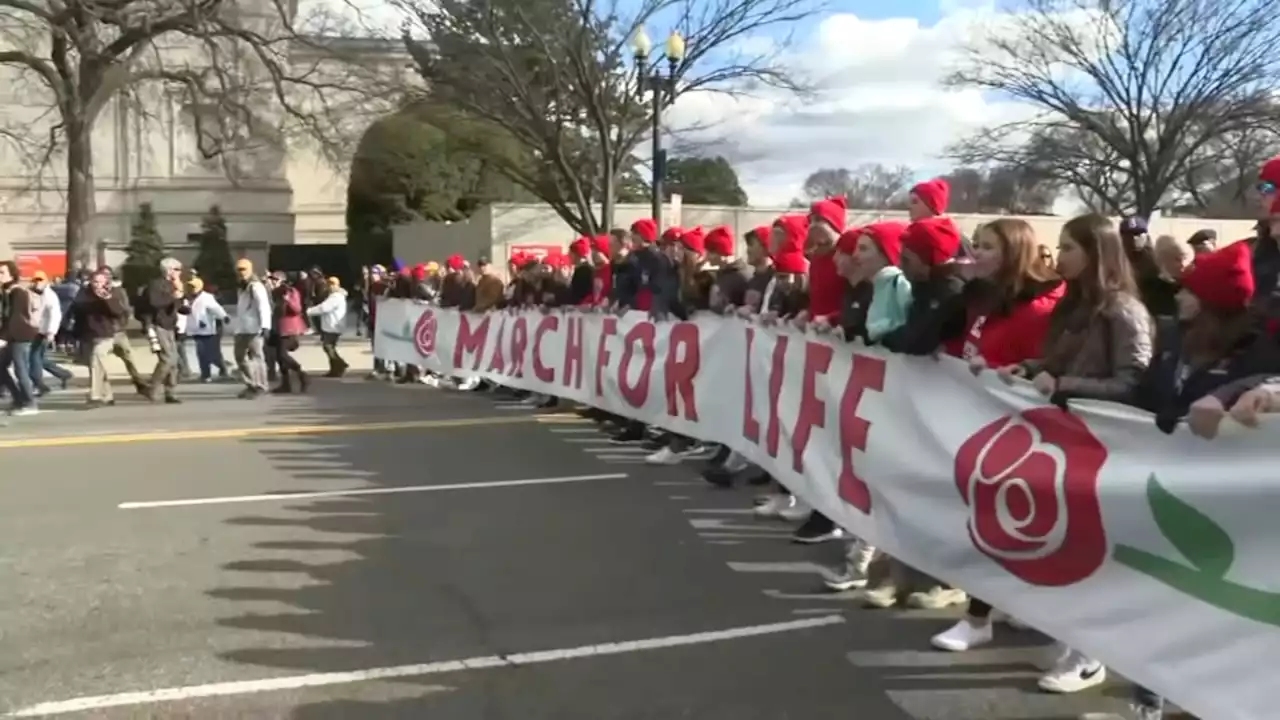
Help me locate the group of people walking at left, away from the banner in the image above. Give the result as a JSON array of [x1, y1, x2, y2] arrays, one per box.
[[0, 258, 360, 415]]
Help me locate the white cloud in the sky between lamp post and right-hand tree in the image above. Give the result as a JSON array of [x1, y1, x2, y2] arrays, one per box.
[[666, 8, 1025, 205]]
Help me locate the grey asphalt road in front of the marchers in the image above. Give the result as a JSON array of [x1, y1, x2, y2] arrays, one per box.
[[0, 379, 1146, 720]]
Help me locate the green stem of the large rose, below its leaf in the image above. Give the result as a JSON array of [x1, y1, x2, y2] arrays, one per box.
[[1111, 544, 1280, 628]]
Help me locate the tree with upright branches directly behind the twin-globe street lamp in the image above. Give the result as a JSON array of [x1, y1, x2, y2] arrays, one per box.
[[394, 0, 813, 233]]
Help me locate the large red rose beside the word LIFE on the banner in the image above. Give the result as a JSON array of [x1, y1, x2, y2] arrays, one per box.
[[955, 407, 1107, 587]]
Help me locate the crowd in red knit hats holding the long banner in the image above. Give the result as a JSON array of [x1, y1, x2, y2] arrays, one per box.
[[384, 158, 1280, 720]]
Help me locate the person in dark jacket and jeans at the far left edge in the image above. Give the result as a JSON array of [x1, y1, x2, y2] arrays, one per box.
[[0, 260, 40, 415]]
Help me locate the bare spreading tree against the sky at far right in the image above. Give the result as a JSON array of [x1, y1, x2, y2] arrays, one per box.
[[950, 0, 1280, 214]]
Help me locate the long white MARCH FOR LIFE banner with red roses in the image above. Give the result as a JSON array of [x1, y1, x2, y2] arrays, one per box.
[[375, 301, 1280, 720]]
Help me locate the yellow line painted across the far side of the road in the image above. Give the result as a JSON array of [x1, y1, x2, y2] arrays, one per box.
[[0, 415, 536, 448]]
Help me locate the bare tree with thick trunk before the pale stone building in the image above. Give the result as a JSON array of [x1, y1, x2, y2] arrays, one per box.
[[0, 0, 396, 266]]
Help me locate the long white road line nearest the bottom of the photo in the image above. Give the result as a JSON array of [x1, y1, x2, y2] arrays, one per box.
[[5, 615, 845, 717]]
